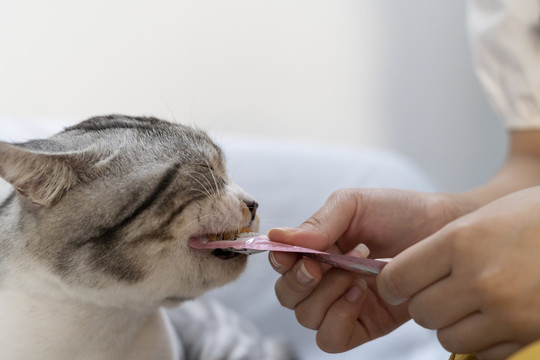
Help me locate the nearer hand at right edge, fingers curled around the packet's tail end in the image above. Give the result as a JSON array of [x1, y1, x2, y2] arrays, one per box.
[[377, 187, 540, 360]]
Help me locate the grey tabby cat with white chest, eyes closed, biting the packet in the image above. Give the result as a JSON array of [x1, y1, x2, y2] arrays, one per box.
[[0, 115, 270, 360]]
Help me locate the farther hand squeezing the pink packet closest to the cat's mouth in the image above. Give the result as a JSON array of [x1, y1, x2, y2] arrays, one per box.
[[268, 189, 462, 352]]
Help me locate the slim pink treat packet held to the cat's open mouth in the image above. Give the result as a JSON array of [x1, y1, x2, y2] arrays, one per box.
[[189, 235, 388, 275]]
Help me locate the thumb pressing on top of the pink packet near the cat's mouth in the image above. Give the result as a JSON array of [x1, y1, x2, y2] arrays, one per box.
[[268, 189, 360, 250]]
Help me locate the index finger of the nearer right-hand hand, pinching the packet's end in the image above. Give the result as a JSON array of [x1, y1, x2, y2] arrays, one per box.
[[377, 228, 452, 305]]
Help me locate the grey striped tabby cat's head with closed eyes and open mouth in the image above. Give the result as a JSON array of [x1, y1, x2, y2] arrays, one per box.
[[0, 115, 257, 305]]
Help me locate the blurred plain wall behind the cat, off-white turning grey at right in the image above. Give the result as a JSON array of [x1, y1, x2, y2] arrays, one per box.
[[0, 0, 506, 191]]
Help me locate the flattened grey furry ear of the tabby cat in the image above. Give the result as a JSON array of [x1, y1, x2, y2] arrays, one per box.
[[0, 142, 96, 206]]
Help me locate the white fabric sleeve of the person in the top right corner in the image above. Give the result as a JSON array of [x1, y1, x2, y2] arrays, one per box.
[[468, 0, 540, 130]]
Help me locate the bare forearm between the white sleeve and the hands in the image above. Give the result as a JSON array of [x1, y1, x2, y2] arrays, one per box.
[[448, 130, 540, 213]]
